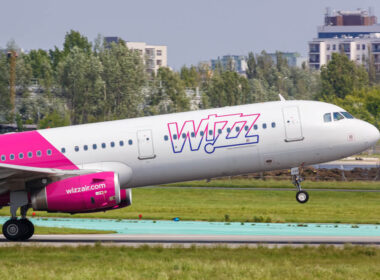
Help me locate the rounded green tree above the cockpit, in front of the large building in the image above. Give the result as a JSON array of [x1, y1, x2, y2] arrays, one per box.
[[319, 53, 368, 101]]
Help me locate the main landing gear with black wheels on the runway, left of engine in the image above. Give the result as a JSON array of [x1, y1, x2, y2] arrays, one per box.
[[3, 191, 34, 241]]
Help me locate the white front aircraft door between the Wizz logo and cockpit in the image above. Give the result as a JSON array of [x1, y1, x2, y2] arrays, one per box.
[[282, 106, 304, 142]]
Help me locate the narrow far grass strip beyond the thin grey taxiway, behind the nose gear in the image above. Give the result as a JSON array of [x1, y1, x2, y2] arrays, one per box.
[[165, 179, 380, 190]]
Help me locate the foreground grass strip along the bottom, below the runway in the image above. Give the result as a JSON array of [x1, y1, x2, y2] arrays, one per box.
[[0, 245, 380, 280]]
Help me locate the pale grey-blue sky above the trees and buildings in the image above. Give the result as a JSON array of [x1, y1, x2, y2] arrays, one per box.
[[0, 0, 380, 70]]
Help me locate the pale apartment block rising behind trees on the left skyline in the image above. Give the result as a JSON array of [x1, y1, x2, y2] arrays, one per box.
[[104, 37, 168, 74]]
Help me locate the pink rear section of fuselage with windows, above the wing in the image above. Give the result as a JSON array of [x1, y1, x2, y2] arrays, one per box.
[[0, 131, 78, 170]]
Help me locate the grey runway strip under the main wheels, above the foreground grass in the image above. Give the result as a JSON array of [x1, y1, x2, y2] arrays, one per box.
[[0, 234, 380, 247]]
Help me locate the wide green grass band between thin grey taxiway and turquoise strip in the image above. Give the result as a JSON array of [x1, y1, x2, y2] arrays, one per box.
[[0, 188, 380, 224]]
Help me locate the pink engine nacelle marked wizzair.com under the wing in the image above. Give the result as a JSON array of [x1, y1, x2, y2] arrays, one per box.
[[31, 172, 132, 213]]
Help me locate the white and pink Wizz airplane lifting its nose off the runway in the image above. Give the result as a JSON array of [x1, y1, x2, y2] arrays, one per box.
[[0, 96, 380, 241]]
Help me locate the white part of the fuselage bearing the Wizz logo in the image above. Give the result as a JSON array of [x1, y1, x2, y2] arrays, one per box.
[[39, 101, 379, 188]]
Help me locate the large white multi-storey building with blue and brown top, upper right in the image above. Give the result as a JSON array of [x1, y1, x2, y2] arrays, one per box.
[[308, 9, 380, 73]]
